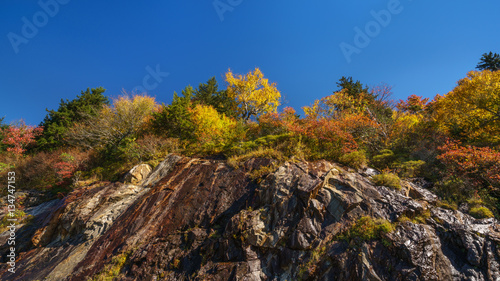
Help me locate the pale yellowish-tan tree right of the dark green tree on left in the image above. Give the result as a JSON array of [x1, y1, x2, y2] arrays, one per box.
[[68, 95, 158, 148]]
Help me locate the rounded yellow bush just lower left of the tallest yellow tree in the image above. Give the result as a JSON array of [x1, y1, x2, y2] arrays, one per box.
[[190, 104, 237, 150]]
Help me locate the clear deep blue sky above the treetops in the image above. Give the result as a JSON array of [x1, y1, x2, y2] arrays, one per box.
[[0, 0, 500, 125]]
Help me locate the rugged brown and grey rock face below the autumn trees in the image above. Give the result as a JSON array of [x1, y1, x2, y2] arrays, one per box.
[[0, 155, 500, 280]]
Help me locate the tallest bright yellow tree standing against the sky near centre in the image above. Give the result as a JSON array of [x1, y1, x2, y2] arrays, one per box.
[[226, 68, 281, 120]]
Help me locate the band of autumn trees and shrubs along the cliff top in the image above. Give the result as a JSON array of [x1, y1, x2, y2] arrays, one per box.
[[0, 57, 500, 217]]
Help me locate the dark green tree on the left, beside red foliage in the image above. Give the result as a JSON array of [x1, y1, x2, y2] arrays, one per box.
[[37, 87, 109, 150]]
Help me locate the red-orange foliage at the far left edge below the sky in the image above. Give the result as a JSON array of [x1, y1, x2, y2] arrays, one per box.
[[2, 121, 43, 156]]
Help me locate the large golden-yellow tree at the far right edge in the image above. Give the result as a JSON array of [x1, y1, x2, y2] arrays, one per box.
[[435, 70, 500, 145]]
